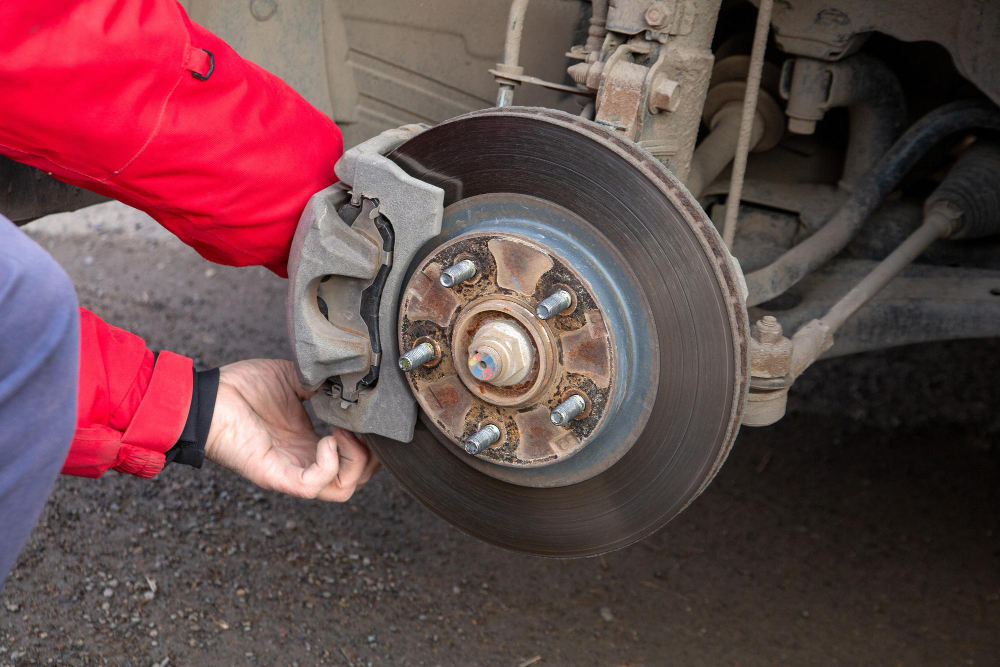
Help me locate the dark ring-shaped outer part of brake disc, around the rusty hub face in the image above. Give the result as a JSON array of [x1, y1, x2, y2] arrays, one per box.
[[368, 107, 748, 557]]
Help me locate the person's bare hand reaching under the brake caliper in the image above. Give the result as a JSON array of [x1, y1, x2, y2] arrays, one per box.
[[205, 359, 379, 502]]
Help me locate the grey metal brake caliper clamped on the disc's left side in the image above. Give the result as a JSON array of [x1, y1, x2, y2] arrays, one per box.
[[286, 126, 444, 442]]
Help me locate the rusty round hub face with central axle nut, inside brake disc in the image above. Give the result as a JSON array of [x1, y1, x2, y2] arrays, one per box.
[[399, 232, 616, 467]]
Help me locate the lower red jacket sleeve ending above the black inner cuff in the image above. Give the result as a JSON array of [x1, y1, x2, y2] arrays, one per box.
[[62, 308, 193, 477]]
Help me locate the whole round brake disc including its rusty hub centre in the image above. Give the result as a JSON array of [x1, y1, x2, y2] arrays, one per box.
[[367, 108, 749, 557]]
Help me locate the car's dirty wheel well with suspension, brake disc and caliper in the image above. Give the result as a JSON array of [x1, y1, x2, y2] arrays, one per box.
[[7, 0, 1000, 557]]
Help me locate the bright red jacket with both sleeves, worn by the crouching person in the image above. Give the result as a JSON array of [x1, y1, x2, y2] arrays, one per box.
[[0, 0, 342, 477]]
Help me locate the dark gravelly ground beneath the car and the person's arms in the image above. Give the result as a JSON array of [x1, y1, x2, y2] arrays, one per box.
[[0, 204, 1000, 667]]
